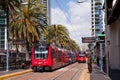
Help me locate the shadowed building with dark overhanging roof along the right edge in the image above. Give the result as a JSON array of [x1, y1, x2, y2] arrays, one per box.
[[105, 0, 120, 70]]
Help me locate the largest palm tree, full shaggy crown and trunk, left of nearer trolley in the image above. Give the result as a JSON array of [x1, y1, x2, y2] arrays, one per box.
[[10, 0, 45, 60]]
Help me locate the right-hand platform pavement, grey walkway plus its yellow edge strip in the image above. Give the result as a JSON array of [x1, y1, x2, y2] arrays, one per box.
[[79, 64, 111, 80]]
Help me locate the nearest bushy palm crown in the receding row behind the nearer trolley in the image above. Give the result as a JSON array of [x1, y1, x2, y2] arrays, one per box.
[[47, 25, 69, 47]]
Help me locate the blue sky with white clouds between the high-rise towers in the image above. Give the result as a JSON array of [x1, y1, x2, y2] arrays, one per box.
[[51, 0, 91, 47]]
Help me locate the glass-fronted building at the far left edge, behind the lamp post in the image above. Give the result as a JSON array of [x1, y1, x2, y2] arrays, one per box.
[[0, 6, 7, 62]]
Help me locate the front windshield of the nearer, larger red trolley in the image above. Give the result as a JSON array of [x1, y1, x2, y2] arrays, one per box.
[[34, 46, 48, 59]]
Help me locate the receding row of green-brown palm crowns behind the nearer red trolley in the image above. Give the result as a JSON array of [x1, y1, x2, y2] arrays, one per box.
[[46, 25, 80, 51]]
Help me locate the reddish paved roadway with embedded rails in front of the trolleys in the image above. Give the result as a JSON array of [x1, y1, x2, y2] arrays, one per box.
[[2, 62, 86, 80]]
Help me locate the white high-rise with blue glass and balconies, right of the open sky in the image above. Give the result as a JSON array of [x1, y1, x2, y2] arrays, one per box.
[[91, 0, 103, 36]]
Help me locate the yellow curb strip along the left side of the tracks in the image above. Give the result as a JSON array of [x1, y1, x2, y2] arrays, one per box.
[[0, 69, 32, 80]]
